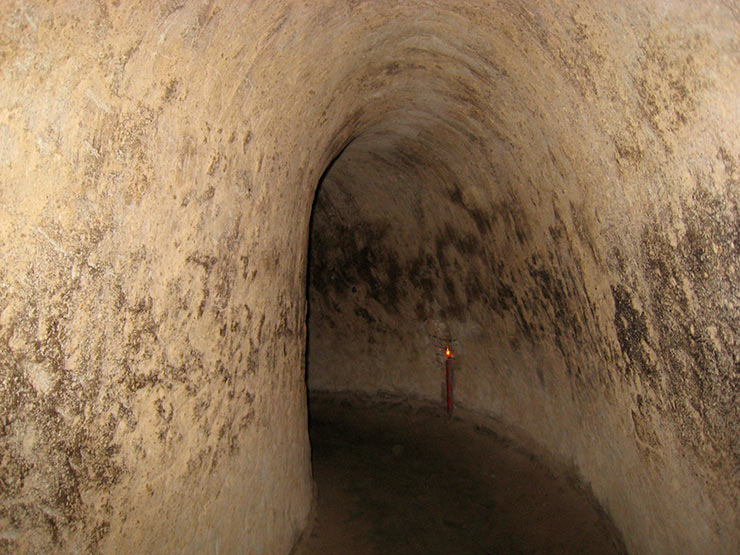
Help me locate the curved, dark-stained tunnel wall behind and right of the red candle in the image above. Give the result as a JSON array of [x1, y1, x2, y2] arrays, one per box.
[[308, 2, 740, 552]]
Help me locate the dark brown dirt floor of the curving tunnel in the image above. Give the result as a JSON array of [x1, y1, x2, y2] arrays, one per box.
[[296, 396, 625, 554]]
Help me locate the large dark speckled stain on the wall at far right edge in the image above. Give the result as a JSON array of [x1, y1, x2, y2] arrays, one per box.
[[641, 179, 740, 478]]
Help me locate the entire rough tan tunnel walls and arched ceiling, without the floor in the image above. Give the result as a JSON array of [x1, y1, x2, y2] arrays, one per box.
[[0, 0, 740, 553]]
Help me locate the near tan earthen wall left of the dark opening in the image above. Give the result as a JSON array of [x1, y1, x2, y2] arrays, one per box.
[[0, 1, 333, 553]]
